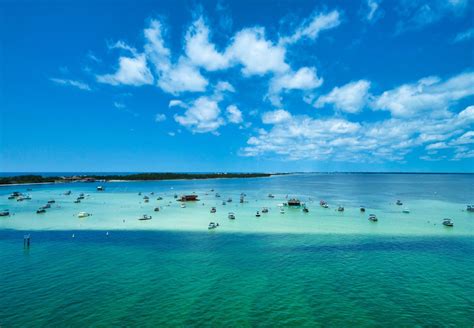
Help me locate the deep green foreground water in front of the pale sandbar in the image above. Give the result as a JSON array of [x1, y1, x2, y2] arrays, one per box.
[[0, 230, 474, 327]]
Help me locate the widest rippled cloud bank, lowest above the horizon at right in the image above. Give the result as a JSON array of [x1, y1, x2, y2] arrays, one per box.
[[241, 107, 474, 162]]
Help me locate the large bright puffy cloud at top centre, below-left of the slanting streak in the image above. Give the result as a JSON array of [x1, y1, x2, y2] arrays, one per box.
[[226, 27, 289, 76]]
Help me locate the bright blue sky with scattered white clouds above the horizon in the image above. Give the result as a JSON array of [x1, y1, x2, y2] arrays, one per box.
[[0, 0, 474, 172]]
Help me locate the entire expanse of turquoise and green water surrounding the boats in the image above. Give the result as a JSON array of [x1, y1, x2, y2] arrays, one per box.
[[0, 175, 474, 327]]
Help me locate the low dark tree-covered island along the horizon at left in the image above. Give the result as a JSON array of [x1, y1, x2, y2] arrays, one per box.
[[0, 173, 273, 185]]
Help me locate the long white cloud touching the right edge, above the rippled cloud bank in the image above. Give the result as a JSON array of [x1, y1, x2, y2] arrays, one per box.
[[371, 72, 474, 117]]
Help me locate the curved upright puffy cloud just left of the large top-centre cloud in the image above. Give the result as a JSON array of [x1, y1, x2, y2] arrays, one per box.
[[185, 17, 229, 71]]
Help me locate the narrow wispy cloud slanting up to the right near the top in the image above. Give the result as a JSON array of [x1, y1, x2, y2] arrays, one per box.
[[280, 10, 341, 45]]
